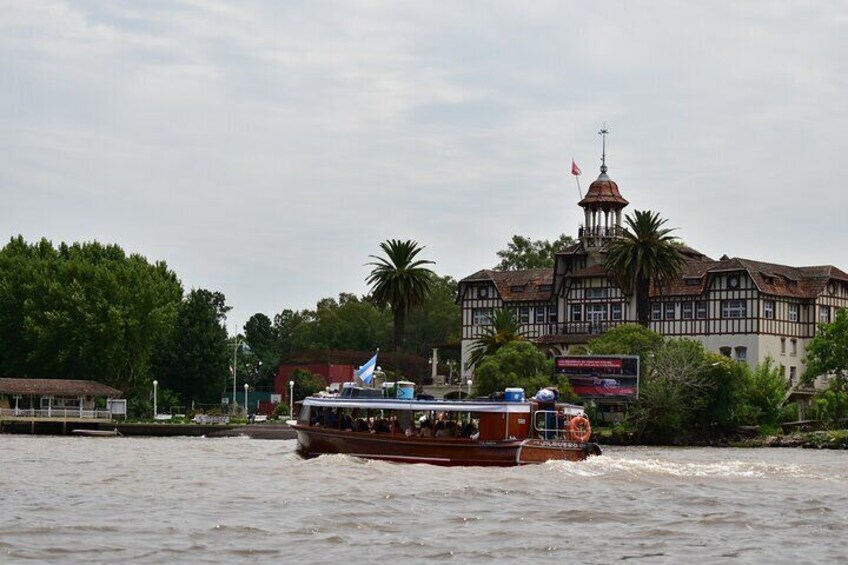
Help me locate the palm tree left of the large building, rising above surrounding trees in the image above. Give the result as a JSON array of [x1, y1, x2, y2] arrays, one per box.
[[365, 239, 435, 351]]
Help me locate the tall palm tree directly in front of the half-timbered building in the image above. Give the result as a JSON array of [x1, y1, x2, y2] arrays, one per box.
[[604, 210, 684, 327]]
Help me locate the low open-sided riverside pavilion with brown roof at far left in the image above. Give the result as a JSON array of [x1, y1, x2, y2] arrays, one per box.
[[0, 378, 126, 421]]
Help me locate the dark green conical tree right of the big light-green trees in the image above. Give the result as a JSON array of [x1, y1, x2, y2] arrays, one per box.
[[158, 289, 232, 407]]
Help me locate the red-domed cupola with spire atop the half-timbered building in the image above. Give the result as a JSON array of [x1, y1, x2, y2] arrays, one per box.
[[579, 129, 629, 247]]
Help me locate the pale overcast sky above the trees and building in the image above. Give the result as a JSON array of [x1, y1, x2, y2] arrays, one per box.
[[0, 0, 848, 329]]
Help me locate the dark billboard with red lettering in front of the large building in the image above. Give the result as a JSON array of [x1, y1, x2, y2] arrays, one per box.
[[554, 355, 639, 400]]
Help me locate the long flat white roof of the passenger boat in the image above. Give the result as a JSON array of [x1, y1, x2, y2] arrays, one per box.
[[303, 396, 583, 415]]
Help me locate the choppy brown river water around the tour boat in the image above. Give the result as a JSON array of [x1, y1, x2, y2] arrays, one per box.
[[0, 435, 848, 564]]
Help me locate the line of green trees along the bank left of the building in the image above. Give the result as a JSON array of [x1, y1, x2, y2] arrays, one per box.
[[0, 236, 460, 413]]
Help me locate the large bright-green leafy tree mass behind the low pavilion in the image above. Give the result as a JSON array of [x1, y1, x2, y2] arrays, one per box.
[[0, 237, 182, 396]]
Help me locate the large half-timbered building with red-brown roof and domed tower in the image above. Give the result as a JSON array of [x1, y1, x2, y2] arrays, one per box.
[[458, 153, 848, 383]]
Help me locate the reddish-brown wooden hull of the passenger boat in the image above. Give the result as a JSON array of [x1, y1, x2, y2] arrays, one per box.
[[292, 424, 600, 467]]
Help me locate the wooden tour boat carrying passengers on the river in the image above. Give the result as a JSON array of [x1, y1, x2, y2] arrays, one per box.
[[290, 389, 601, 466]]
